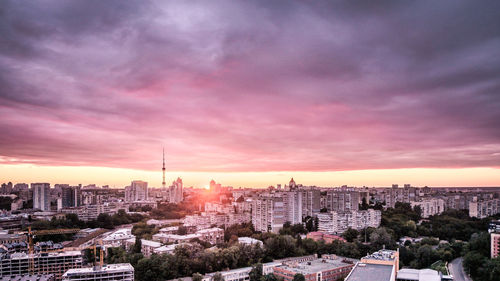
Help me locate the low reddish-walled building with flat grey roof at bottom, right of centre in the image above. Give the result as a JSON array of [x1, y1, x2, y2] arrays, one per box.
[[273, 255, 356, 281]]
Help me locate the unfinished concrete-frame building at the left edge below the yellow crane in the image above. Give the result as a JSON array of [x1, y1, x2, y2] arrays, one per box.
[[0, 251, 83, 280]]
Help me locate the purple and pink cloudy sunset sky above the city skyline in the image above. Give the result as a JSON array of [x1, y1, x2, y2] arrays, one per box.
[[0, 0, 500, 187]]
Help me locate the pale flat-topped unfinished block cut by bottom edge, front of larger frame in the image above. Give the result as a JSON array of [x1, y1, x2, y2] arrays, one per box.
[[62, 263, 134, 281]]
